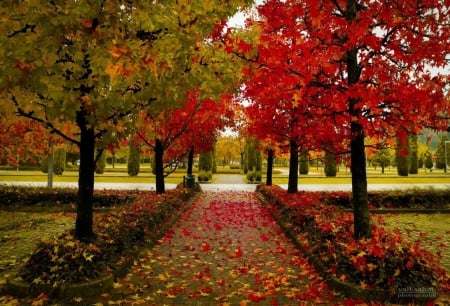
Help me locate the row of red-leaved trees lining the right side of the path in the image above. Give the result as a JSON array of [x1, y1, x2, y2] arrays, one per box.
[[241, 0, 450, 238]]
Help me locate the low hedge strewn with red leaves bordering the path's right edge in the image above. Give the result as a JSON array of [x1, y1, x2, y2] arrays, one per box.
[[259, 186, 450, 299]]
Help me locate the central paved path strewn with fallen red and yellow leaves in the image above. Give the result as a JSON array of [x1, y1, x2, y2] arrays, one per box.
[[102, 191, 339, 305]]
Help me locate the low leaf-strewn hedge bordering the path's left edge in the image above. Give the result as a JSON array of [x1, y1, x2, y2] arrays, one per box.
[[15, 189, 196, 288]]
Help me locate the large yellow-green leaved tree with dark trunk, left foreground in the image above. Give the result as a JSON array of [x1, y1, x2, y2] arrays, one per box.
[[0, 0, 253, 240]]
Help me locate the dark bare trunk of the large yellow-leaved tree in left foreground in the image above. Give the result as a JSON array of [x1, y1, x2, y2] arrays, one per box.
[[75, 110, 95, 240]]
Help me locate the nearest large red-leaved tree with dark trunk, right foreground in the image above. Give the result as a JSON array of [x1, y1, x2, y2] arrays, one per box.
[[243, 0, 450, 238]]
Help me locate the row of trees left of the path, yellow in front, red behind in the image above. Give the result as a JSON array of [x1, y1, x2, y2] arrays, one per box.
[[0, 0, 250, 240]]
